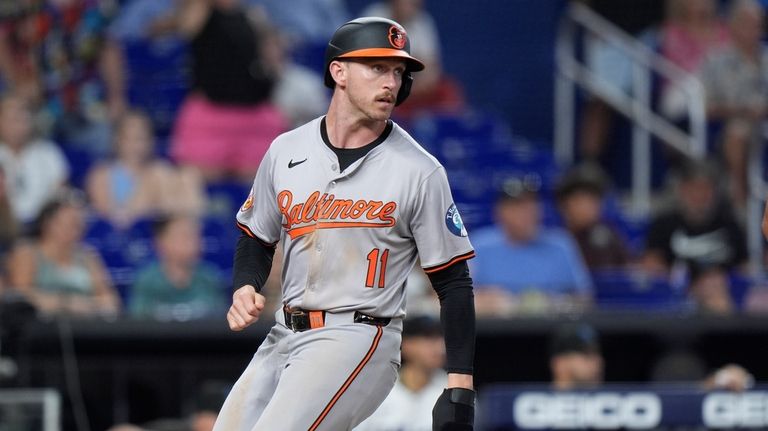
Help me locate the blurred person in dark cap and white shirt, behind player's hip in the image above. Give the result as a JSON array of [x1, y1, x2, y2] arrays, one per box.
[[355, 316, 448, 431]]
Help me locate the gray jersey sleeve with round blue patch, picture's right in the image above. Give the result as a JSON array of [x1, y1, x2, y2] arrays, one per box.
[[411, 167, 475, 274]]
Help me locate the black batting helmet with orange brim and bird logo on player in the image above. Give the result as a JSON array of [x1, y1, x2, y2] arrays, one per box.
[[325, 17, 424, 106]]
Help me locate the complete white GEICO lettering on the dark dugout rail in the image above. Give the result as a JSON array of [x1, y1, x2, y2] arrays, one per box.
[[514, 392, 662, 429]]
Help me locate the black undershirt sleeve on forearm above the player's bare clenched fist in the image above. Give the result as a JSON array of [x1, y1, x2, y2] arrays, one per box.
[[232, 234, 275, 292]]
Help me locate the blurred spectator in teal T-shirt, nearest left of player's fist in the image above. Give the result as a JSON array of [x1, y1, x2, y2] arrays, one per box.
[[129, 216, 226, 320]]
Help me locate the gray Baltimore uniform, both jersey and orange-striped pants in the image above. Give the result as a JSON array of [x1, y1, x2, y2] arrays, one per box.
[[214, 119, 474, 431]]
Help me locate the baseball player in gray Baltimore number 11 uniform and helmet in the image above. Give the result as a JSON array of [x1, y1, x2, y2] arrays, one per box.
[[214, 18, 475, 431]]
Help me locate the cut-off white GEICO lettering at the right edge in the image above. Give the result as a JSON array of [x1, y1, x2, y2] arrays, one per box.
[[701, 392, 768, 428]]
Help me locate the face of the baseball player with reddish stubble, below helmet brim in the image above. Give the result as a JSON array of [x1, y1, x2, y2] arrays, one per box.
[[345, 58, 405, 121]]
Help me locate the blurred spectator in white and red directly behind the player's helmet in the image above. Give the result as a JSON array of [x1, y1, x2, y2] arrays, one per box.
[[362, 0, 464, 119]]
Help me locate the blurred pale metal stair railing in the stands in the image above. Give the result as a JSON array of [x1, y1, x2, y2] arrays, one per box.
[[555, 2, 707, 215]]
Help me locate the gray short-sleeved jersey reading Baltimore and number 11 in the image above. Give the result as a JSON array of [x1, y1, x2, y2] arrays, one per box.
[[237, 118, 474, 317]]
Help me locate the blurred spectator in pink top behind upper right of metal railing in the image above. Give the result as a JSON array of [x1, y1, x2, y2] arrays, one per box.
[[659, 0, 729, 120]]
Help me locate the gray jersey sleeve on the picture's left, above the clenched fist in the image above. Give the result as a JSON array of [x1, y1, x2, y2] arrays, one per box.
[[236, 151, 281, 245]]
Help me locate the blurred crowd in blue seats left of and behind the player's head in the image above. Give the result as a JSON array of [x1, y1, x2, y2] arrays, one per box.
[[0, 0, 464, 320]]
